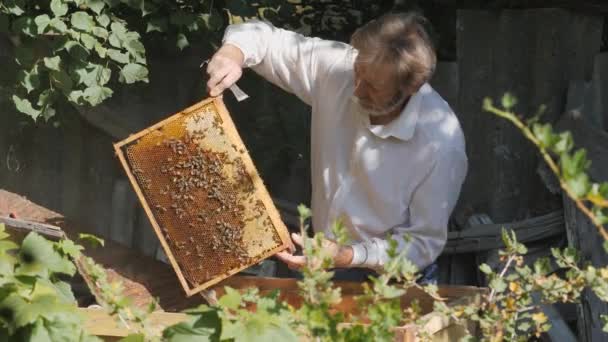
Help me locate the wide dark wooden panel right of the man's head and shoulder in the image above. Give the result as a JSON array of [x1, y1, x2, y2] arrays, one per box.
[[456, 9, 603, 222]]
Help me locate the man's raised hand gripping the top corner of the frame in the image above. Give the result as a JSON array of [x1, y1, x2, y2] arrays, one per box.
[[207, 44, 245, 97]]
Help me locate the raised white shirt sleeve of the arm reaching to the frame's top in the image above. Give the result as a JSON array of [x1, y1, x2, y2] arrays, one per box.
[[223, 20, 352, 105]]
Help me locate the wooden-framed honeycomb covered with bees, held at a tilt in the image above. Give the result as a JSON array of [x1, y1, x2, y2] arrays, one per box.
[[115, 98, 289, 296]]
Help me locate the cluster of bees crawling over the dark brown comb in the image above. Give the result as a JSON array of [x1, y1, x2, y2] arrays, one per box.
[[143, 134, 262, 281]]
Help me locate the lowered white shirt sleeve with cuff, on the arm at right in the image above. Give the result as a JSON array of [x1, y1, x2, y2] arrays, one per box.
[[351, 150, 467, 270]]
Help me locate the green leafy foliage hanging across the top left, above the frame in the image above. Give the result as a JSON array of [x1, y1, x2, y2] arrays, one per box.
[[0, 0, 380, 120]]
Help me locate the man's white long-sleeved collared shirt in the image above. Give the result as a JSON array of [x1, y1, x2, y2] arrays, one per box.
[[223, 21, 467, 270]]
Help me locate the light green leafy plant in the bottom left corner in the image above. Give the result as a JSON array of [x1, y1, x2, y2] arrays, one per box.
[[0, 224, 100, 341]]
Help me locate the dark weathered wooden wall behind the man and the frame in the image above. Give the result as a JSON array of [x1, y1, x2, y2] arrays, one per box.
[[0, 0, 608, 341]]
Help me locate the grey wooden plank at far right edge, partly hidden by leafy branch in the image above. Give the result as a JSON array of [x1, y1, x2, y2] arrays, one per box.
[[557, 108, 608, 341]]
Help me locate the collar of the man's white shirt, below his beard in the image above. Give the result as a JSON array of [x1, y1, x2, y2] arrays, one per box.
[[364, 84, 431, 141]]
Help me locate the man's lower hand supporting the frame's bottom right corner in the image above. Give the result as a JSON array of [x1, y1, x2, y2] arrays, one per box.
[[276, 233, 353, 270]]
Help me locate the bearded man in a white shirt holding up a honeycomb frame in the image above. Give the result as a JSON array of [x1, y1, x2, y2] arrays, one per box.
[[207, 13, 467, 279]]
